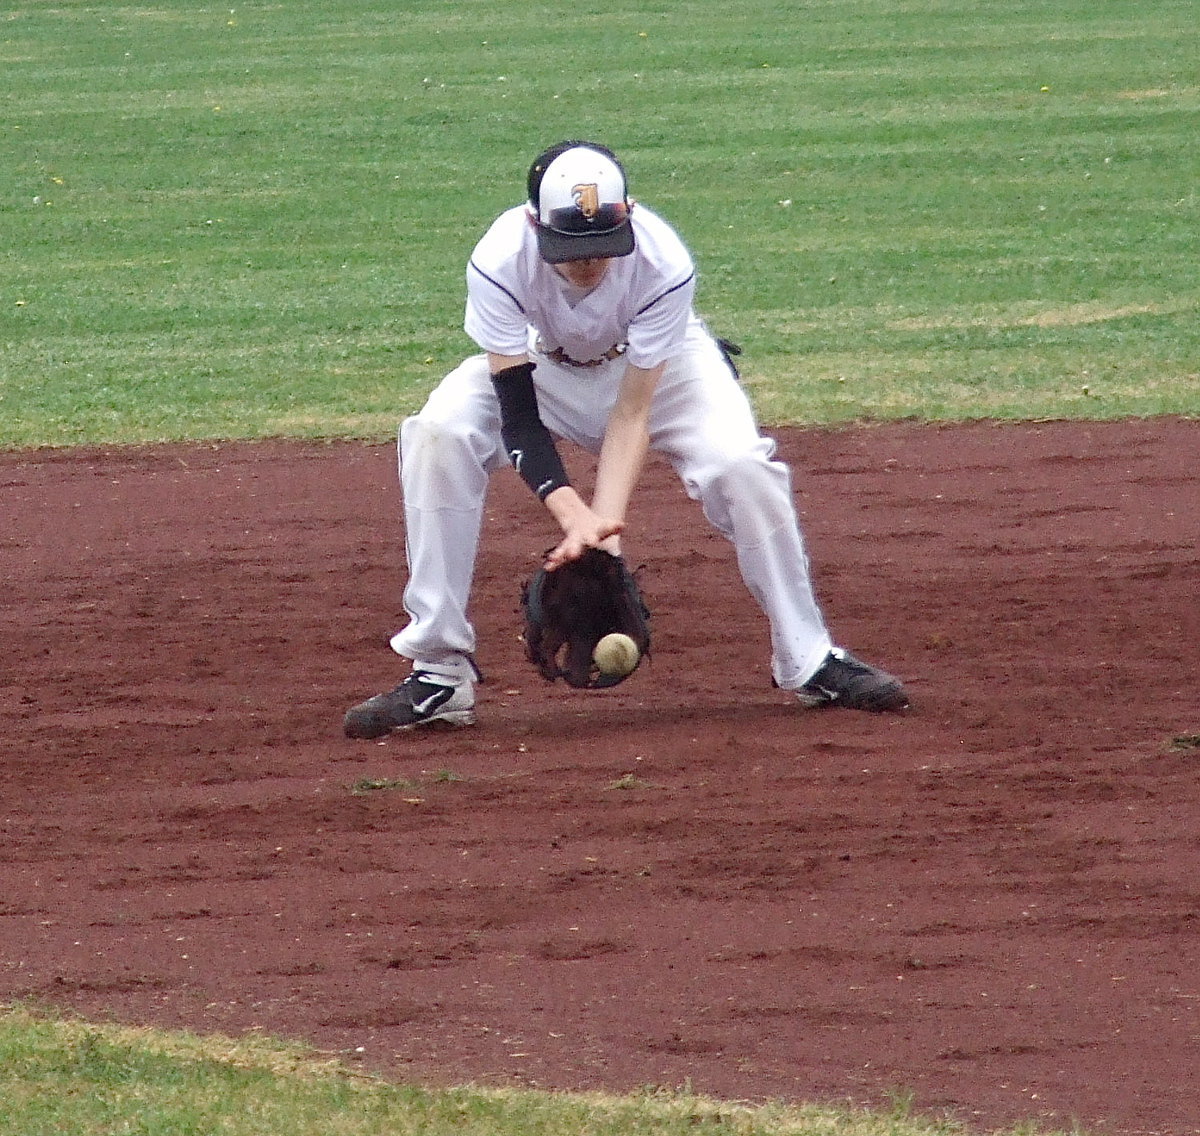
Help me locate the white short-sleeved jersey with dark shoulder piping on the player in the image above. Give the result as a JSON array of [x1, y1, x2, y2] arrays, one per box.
[[463, 205, 700, 368]]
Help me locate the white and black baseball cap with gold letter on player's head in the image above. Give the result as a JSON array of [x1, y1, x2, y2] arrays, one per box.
[[529, 143, 634, 264]]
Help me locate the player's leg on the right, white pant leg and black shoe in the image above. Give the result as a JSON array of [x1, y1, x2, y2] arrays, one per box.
[[650, 330, 902, 709]]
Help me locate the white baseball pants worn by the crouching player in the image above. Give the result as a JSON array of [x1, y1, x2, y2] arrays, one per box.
[[391, 327, 833, 690]]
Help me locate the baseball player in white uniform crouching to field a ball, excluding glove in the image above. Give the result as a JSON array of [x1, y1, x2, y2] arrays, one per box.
[[343, 142, 908, 738]]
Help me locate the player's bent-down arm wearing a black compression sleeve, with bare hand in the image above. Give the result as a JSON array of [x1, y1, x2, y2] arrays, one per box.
[[487, 353, 622, 567]]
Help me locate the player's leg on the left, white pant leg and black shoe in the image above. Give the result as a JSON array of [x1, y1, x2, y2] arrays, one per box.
[[343, 356, 506, 738]]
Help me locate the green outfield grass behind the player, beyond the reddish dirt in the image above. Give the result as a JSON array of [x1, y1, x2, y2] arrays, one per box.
[[0, 0, 1200, 447]]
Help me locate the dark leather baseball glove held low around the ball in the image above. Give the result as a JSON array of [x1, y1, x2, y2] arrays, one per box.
[[521, 548, 650, 687]]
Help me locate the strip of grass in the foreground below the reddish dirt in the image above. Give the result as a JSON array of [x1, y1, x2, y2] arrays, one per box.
[[0, 1008, 1075, 1136]]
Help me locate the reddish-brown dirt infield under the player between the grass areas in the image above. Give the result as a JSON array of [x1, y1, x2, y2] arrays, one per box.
[[0, 420, 1200, 1136]]
